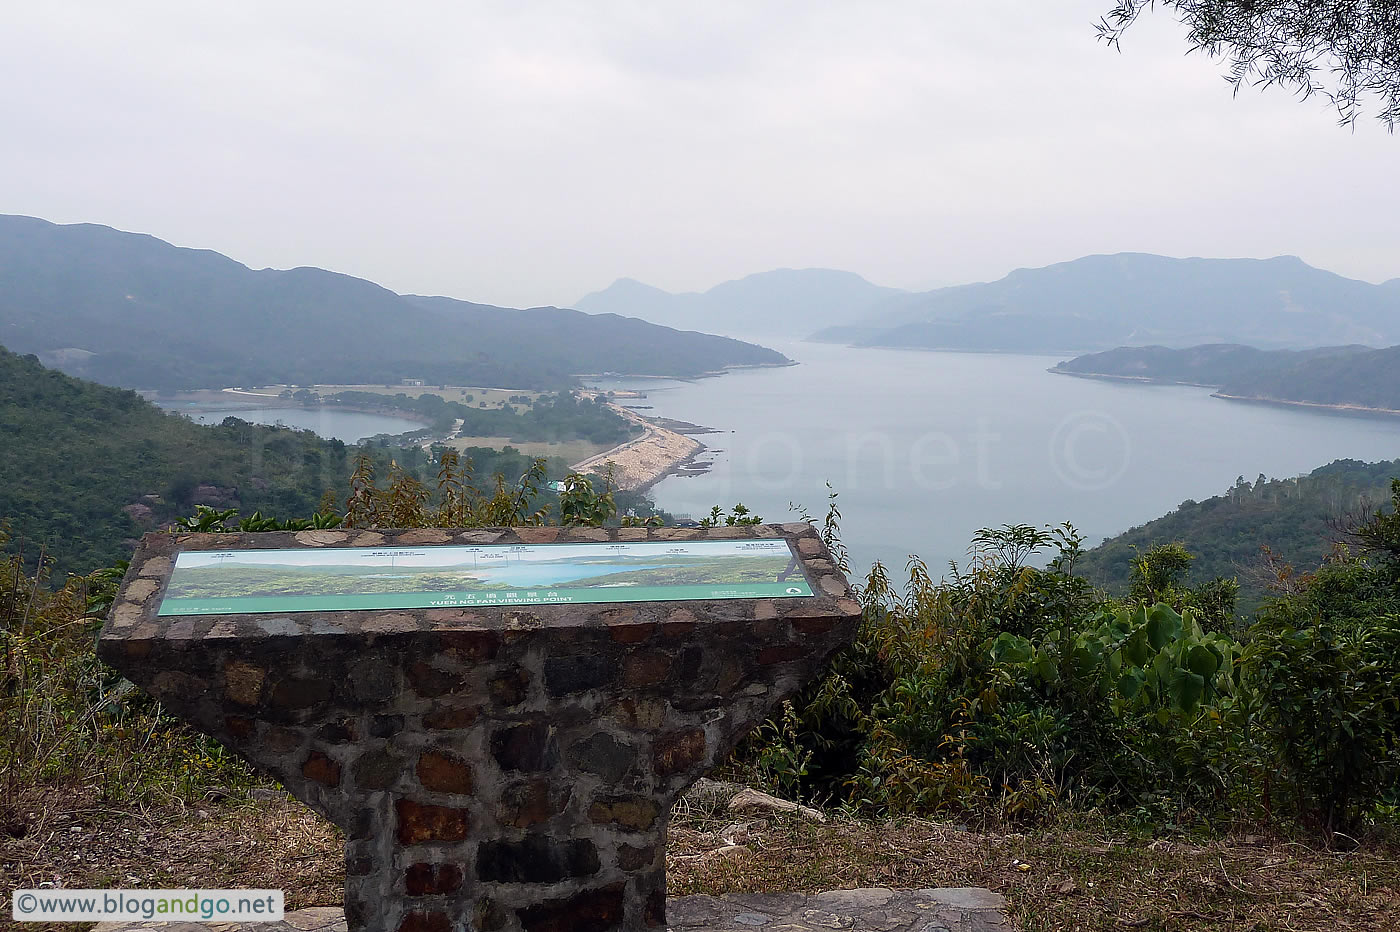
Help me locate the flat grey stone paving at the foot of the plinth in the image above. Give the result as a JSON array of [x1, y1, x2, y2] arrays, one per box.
[[94, 887, 1015, 932]]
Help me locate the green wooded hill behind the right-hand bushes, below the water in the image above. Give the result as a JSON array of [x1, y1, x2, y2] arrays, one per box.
[[1075, 459, 1400, 610]]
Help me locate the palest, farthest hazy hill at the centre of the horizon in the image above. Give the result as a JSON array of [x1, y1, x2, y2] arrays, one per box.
[[574, 269, 903, 339]]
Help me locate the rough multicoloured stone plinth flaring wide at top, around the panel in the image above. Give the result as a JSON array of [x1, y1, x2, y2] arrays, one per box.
[[99, 523, 860, 932]]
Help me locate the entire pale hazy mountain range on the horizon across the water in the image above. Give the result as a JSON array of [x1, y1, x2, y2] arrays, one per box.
[[575, 253, 1400, 353]]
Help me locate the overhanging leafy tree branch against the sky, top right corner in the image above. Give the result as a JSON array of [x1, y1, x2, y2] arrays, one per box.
[[1098, 0, 1400, 132]]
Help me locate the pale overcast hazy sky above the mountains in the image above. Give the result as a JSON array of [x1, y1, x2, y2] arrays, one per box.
[[0, 0, 1400, 305]]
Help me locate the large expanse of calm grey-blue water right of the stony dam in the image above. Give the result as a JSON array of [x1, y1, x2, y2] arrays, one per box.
[[596, 343, 1400, 578]]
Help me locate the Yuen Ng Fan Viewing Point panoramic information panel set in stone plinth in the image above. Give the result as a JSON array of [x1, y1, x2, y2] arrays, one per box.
[[160, 540, 812, 614]]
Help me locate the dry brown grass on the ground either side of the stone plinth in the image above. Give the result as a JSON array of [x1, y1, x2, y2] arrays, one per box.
[[0, 791, 1400, 932]]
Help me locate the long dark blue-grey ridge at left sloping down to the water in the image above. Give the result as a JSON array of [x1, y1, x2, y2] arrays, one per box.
[[0, 216, 787, 389]]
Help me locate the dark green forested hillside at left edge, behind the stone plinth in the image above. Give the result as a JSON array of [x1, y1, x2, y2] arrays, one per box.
[[0, 348, 560, 579]]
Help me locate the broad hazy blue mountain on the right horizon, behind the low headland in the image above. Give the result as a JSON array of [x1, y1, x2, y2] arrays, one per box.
[[812, 253, 1400, 353]]
